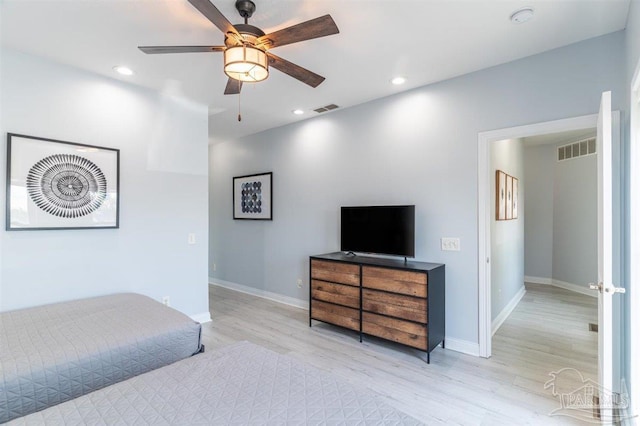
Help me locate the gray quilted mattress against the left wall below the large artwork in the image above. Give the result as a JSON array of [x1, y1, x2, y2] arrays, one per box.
[[0, 293, 201, 423]]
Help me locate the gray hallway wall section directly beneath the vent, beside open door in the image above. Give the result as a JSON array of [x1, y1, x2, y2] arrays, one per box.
[[550, 147, 598, 288]]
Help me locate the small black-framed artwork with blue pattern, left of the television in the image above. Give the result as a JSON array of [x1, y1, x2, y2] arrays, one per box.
[[233, 172, 273, 220]]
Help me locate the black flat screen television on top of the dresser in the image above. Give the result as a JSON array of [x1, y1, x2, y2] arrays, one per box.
[[340, 206, 416, 257]]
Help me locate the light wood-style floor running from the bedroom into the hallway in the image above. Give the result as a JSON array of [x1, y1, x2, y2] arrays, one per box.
[[203, 284, 597, 425]]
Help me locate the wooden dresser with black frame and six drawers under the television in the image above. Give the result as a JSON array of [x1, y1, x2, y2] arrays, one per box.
[[309, 252, 445, 362]]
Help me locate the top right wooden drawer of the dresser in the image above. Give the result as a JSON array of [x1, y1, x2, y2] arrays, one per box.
[[362, 266, 427, 297]]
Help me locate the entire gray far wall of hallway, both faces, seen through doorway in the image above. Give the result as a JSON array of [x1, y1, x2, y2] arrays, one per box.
[[524, 141, 598, 288]]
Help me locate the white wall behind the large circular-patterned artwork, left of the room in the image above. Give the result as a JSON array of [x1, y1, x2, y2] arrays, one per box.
[[0, 50, 208, 315]]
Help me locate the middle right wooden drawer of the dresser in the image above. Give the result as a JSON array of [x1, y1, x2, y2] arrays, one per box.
[[362, 289, 427, 323]]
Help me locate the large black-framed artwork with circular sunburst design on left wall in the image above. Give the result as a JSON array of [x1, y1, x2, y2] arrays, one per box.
[[6, 133, 120, 231]]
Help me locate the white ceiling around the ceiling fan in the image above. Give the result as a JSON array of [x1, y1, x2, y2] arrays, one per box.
[[0, 0, 630, 141]]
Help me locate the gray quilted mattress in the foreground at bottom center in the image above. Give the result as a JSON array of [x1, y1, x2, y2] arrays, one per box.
[[10, 342, 420, 426]]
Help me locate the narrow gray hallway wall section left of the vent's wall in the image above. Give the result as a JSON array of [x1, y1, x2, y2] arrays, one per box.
[[524, 145, 556, 279]]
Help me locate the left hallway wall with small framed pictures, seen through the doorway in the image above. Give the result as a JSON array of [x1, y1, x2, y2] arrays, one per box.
[[489, 139, 528, 320]]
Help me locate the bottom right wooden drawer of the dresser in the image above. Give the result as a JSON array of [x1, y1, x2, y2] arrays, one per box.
[[362, 312, 427, 350]]
